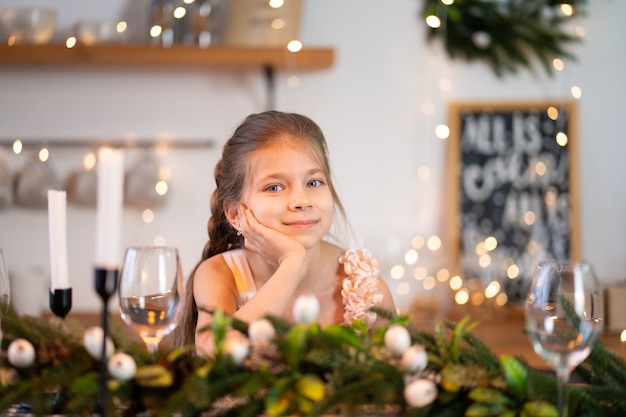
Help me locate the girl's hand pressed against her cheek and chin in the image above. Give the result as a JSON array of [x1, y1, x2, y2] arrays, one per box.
[[239, 205, 306, 265]]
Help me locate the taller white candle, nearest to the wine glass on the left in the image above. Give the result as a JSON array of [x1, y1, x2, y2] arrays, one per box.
[[95, 148, 124, 269]]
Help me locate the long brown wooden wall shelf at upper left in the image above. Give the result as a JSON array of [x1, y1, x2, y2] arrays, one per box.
[[0, 44, 334, 70]]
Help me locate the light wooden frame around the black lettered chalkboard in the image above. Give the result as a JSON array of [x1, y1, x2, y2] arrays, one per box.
[[443, 101, 581, 286]]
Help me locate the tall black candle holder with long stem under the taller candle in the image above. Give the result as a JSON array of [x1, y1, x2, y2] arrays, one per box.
[[95, 267, 119, 417]]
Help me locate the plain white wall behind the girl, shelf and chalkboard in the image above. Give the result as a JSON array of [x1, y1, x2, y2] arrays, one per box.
[[0, 0, 626, 310]]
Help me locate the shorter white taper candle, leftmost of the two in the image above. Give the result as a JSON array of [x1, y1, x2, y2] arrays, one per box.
[[48, 190, 70, 291]]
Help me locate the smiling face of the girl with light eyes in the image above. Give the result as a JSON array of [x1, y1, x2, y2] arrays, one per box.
[[242, 141, 335, 248]]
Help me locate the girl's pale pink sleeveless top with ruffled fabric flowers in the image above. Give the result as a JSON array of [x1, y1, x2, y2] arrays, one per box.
[[222, 245, 383, 326]]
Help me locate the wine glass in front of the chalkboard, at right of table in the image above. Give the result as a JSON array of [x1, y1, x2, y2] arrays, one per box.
[[525, 262, 603, 417]]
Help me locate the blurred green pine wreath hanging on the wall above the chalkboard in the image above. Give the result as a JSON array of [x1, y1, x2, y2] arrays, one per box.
[[422, 0, 586, 76]]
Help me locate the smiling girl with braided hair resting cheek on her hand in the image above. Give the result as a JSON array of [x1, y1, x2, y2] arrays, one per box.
[[176, 111, 395, 353]]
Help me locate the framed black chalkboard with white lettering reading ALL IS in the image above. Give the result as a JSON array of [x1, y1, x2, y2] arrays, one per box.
[[446, 102, 580, 299]]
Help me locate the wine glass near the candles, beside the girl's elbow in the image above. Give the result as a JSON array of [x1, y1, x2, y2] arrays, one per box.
[[118, 246, 184, 355]]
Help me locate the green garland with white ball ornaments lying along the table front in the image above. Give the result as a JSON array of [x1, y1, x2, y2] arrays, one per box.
[[0, 303, 626, 417]]
